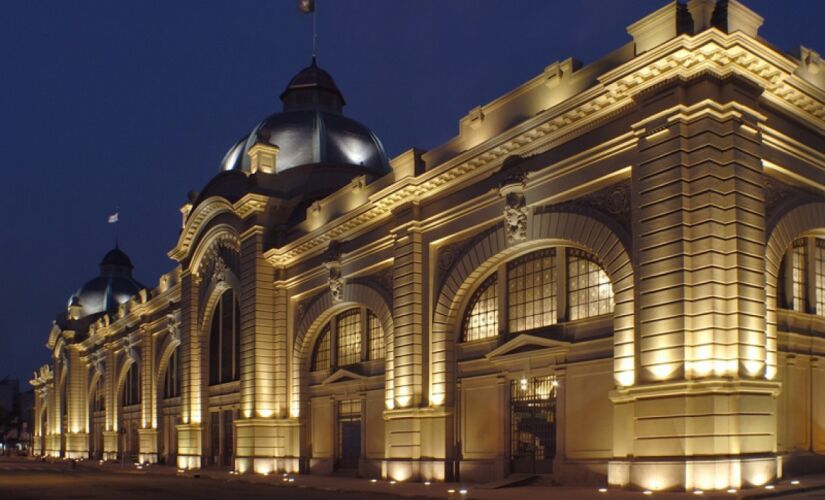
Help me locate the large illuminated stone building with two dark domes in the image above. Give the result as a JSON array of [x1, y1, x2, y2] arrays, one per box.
[[32, 0, 825, 490]]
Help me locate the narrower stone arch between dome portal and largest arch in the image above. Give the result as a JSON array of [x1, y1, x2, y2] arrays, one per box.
[[290, 281, 393, 417]]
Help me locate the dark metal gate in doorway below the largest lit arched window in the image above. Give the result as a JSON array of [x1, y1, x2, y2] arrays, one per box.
[[510, 376, 556, 474]]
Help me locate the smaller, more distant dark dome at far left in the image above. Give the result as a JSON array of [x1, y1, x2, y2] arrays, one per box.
[[69, 247, 146, 318]]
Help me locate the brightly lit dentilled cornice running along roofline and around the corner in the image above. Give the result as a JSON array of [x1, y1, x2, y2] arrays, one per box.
[[258, 29, 825, 266]]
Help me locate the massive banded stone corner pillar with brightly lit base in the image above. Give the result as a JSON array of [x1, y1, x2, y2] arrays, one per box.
[[609, 76, 779, 490]]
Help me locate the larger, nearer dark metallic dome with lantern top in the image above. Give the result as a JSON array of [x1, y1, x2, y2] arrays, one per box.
[[221, 59, 389, 176]]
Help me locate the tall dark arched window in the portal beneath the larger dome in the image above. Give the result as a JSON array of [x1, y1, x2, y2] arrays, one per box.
[[209, 290, 241, 385]]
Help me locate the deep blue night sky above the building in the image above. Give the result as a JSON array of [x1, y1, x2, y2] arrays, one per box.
[[0, 0, 825, 386]]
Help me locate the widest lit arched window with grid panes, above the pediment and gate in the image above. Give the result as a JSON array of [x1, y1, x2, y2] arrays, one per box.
[[462, 247, 614, 342]]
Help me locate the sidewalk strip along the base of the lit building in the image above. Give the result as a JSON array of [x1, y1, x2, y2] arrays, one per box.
[[71, 461, 825, 500]]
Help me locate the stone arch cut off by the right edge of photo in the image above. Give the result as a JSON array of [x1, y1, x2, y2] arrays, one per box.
[[765, 202, 825, 380]]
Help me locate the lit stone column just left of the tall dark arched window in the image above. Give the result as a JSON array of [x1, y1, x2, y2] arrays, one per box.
[[177, 270, 203, 469]]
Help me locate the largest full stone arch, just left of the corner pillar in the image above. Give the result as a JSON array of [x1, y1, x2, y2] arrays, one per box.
[[429, 210, 635, 405]]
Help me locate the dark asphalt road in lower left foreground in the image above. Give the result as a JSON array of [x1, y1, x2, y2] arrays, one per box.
[[0, 460, 408, 500]]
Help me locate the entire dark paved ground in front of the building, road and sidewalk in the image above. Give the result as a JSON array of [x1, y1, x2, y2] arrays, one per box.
[[0, 458, 825, 500]]
